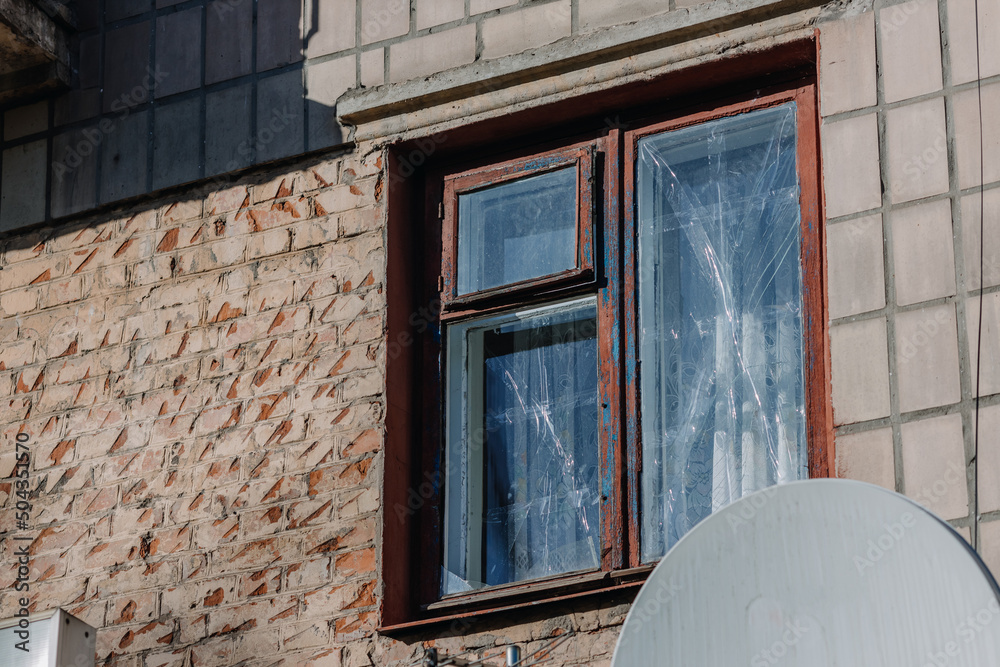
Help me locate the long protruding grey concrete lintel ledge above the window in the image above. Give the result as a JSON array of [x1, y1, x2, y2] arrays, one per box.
[[337, 0, 827, 126]]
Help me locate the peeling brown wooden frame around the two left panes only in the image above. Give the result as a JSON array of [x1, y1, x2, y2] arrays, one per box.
[[430, 132, 624, 612]]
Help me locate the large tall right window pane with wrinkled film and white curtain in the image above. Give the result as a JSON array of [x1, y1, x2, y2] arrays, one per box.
[[637, 104, 808, 561]]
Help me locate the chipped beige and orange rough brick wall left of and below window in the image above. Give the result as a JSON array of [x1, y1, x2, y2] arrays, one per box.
[[0, 147, 626, 667]]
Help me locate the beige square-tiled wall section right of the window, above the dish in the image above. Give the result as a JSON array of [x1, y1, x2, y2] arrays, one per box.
[[819, 0, 1000, 548]]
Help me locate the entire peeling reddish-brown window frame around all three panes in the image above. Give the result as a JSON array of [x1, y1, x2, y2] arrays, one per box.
[[380, 41, 834, 633]]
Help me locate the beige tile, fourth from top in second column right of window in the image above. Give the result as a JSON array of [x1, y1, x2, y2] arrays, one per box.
[[896, 303, 962, 412]]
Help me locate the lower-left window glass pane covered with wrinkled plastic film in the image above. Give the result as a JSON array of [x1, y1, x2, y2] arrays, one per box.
[[442, 298, 600, 593]]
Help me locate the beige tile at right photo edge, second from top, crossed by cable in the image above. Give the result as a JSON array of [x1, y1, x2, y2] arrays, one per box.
[[954, 83, 1000, 189]]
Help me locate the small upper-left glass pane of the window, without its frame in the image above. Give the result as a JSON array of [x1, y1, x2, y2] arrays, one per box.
[[457, 167, 577, 295]]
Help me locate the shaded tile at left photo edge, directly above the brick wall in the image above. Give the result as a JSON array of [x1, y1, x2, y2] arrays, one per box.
[[0, 139, 47, 231]]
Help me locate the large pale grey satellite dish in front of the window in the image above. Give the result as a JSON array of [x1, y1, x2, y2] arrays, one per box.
[[611, 480, 1000, 667]]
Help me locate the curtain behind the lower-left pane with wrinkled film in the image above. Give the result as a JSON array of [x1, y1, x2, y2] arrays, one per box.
[[483, 308, 599, 585]]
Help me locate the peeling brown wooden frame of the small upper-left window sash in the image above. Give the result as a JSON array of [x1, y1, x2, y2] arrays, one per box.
[[441, 146, 596, 311]]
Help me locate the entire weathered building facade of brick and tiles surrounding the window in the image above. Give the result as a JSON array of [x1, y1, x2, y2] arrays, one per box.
[[0, 0, 1000, 667]]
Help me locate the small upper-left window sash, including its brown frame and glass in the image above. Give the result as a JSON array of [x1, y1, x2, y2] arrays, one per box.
[[441, 146, 594, 310]]
